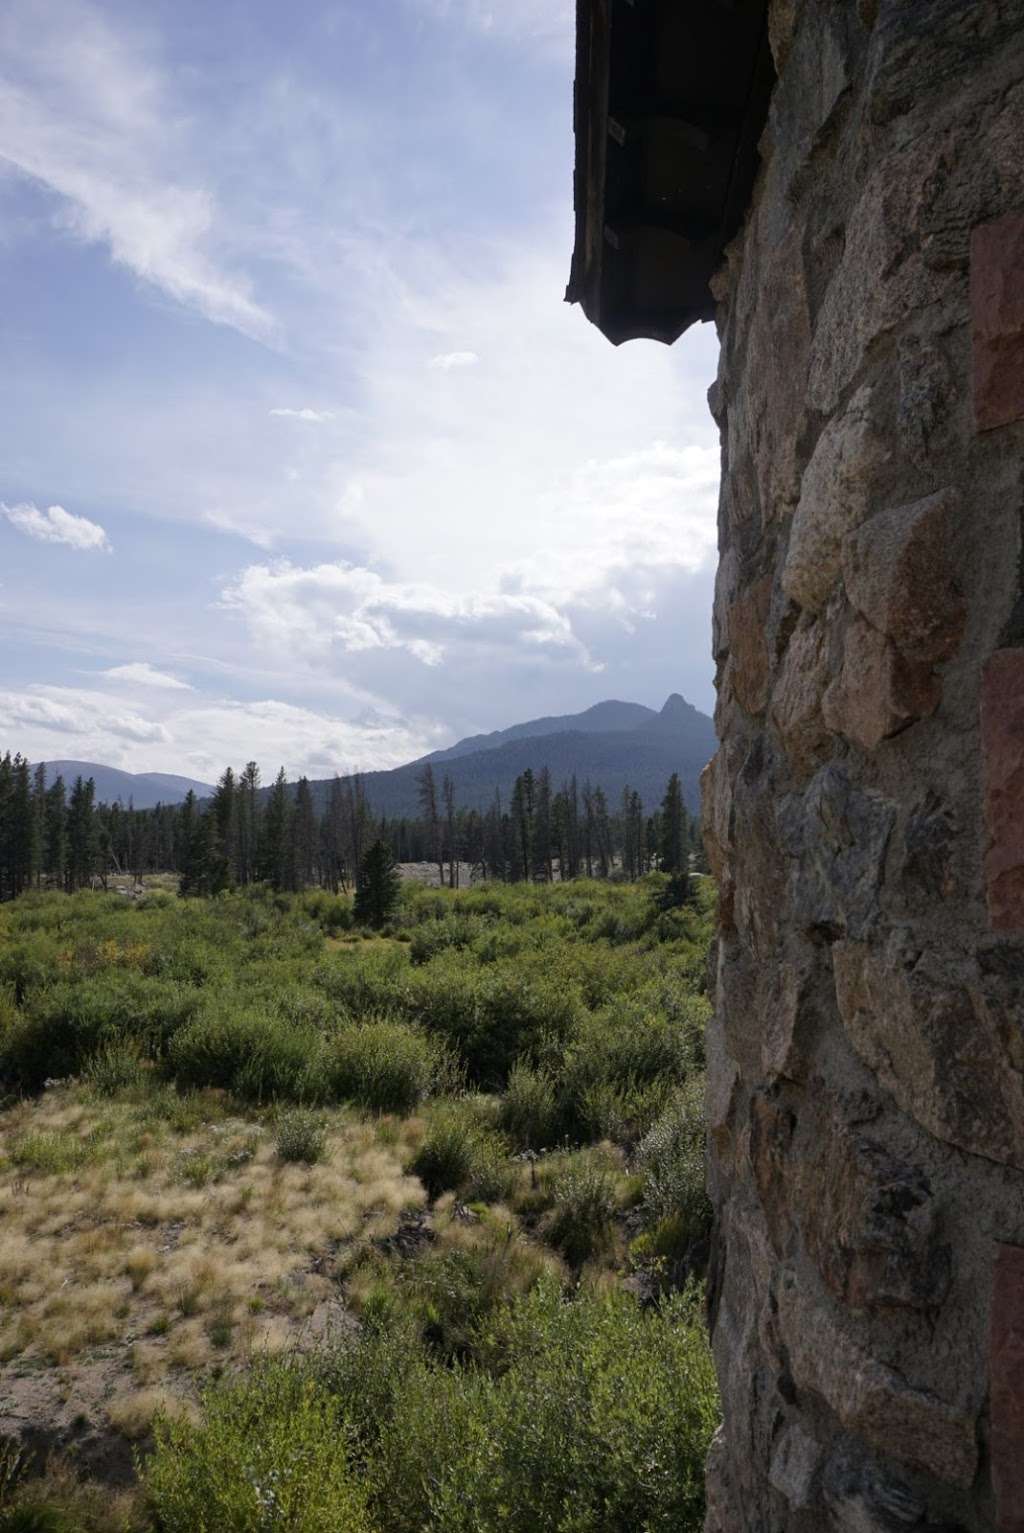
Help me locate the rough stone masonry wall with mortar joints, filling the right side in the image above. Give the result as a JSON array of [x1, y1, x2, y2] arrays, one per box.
[[705, 0, 1024, 1533]]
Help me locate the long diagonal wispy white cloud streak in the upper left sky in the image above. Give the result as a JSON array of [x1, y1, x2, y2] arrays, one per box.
[[0, 0, 274, 339]]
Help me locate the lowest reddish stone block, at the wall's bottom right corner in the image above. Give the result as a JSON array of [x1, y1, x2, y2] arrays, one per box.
[[989, 1246, 1024, 1533]]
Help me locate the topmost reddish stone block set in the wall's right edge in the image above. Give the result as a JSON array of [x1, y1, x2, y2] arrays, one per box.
[[970, 213, 1024, 431]]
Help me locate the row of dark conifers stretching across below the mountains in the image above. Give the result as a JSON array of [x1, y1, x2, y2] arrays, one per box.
[[0, 753, 702, 900]]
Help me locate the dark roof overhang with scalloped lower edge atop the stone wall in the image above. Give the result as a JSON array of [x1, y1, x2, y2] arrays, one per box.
[[566, 0, 774, 345]]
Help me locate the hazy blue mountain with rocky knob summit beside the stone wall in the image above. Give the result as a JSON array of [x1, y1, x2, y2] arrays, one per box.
[[300, 693, 716, 819]]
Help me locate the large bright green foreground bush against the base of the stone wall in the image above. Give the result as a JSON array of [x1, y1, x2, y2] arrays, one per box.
[[331, 1282, 717, 1533]]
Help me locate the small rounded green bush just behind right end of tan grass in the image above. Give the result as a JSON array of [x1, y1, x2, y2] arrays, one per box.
[[320, 1021, 445, 1113]]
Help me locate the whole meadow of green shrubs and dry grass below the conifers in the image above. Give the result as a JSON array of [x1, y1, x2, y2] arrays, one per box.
[[0, 874, 717, 1533]]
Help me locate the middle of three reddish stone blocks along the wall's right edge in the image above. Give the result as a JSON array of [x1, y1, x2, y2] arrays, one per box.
[[981, 650, 1024, 932]]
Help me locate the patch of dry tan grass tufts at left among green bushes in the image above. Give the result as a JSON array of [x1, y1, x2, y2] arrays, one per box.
[[0, 1085, 423, 1404]]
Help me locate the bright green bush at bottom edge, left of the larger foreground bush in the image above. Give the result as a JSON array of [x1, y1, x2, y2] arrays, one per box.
[[143, 1363, 371, 1533]]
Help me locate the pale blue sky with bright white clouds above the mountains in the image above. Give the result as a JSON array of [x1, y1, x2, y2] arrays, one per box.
[[0, 0, 717, 779]]
